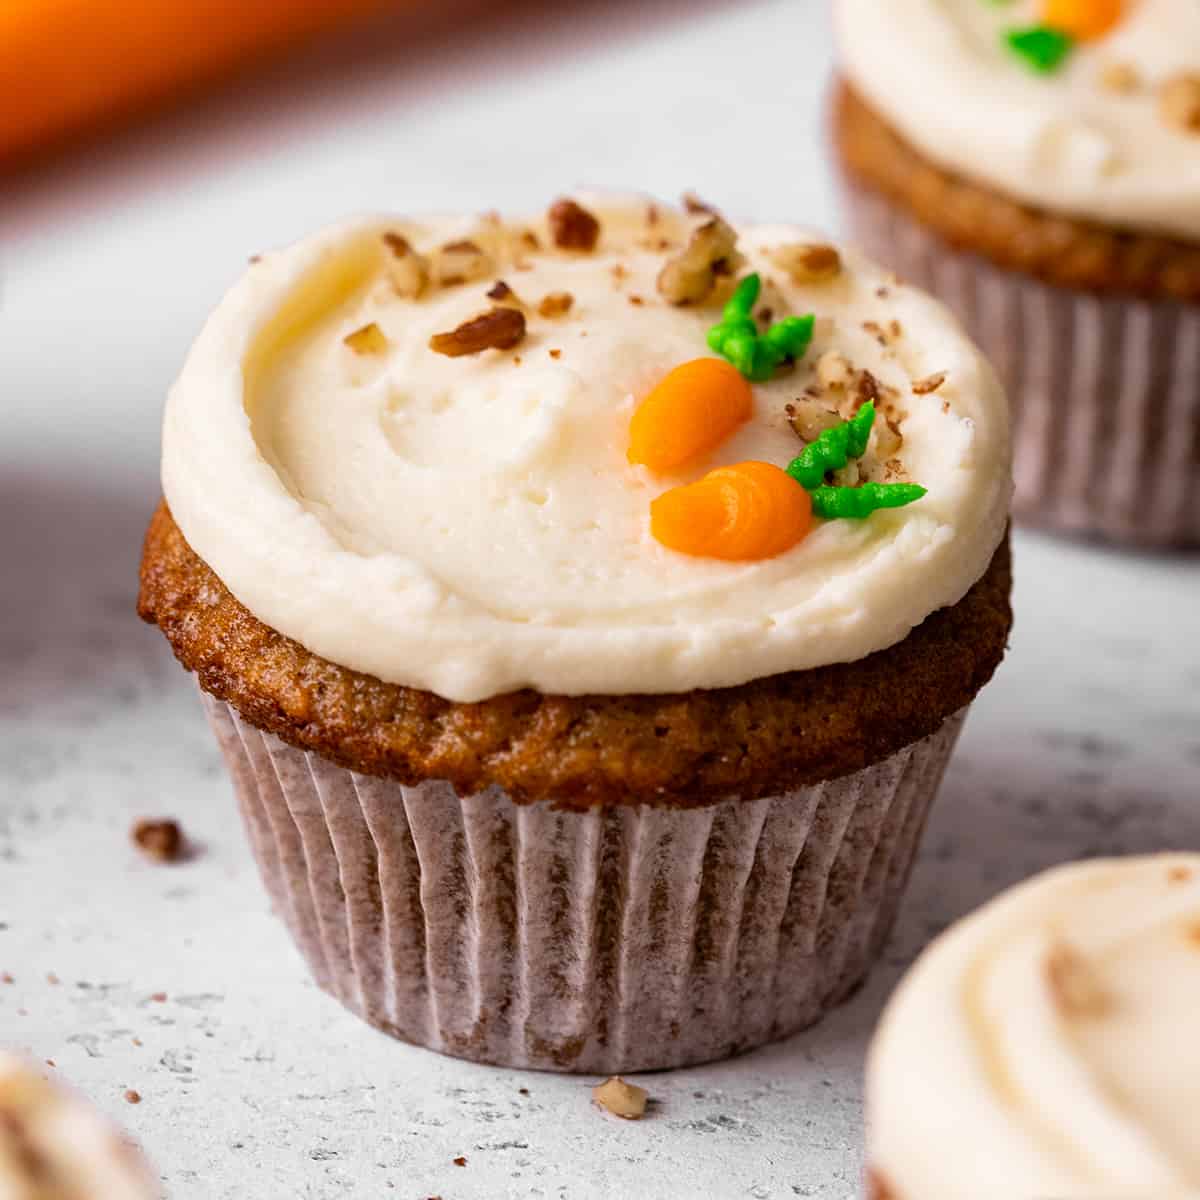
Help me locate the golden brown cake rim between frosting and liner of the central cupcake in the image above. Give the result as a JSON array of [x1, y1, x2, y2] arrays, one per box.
[[138, 503, 1012, 809]]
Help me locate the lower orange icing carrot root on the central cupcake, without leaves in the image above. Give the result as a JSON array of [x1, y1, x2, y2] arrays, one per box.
[[650, 462, 812, 562]]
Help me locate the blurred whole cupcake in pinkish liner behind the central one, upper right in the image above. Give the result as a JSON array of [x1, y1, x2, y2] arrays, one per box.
[[833, 0, 1200, 547]]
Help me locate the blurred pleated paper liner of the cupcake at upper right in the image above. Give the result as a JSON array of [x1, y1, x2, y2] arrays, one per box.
[[844, 178, 1200, 546]]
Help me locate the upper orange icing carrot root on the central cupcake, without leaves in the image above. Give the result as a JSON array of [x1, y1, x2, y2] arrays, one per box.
[[629, 359, 754, 472]]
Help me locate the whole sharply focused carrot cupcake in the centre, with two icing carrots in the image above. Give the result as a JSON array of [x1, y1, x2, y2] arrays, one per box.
[[139, 197, 1010, 1074]]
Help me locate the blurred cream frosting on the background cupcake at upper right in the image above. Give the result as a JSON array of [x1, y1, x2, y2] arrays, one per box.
[[835, 0, 1200, 240]]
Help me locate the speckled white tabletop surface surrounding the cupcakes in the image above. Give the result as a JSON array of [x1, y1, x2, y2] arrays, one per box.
[[0, 0, 1200, 1200]]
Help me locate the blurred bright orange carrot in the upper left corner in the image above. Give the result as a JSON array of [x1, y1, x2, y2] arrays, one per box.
[[0, 0, 383, 166]]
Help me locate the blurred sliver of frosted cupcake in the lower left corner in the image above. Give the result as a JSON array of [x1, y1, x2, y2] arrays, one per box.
[[0, 1052, 160, 1200]]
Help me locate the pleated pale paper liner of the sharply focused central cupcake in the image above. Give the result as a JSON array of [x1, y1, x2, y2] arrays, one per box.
[[202, 692, 965, 1074]]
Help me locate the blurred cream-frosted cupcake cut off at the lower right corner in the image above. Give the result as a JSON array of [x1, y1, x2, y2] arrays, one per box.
[[866, 854, 1200, 1200]]
